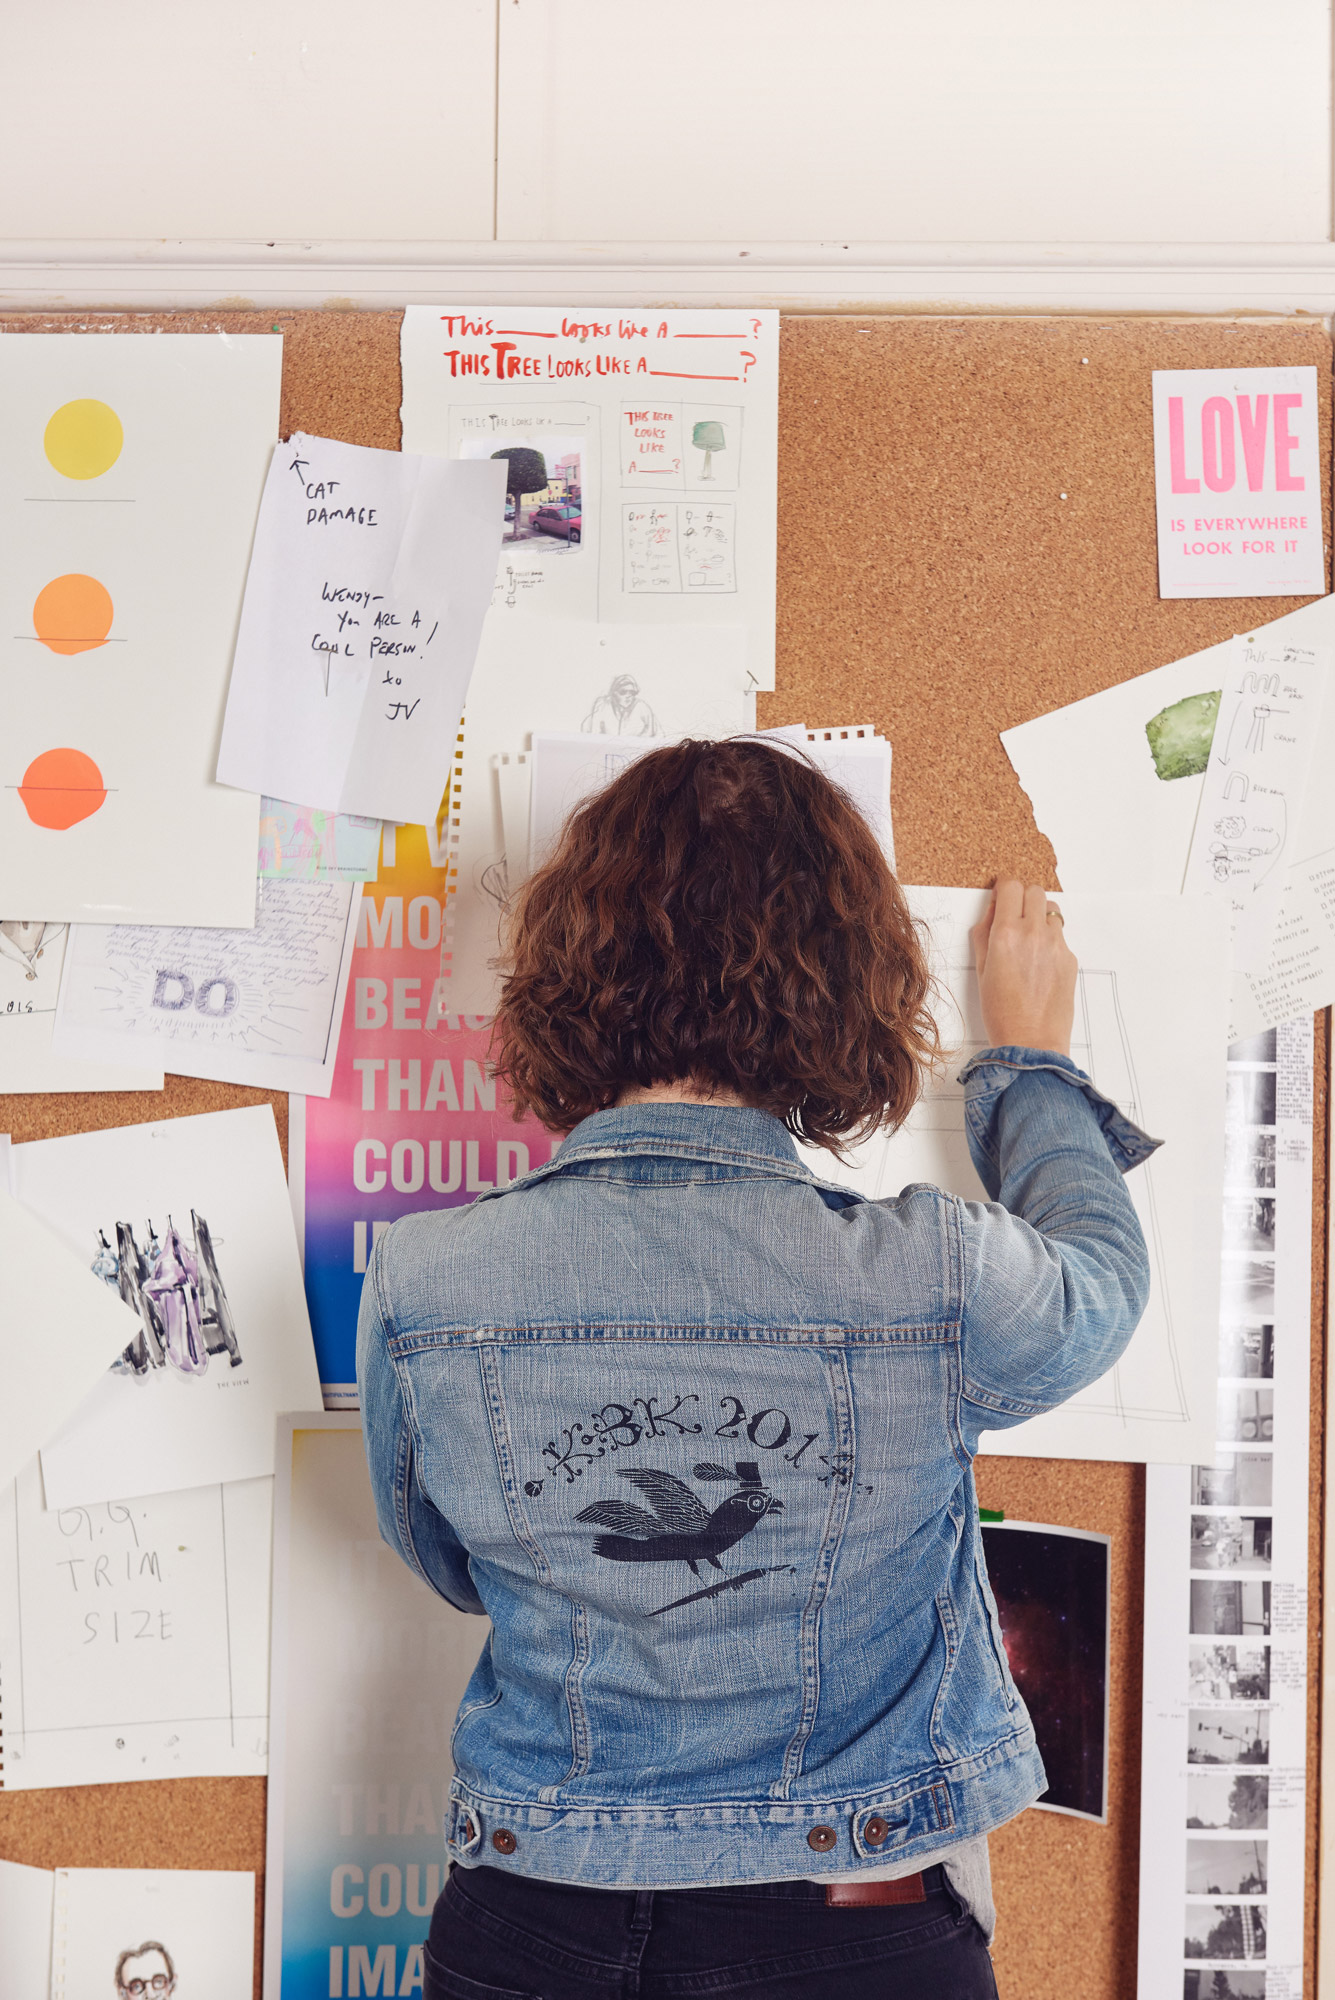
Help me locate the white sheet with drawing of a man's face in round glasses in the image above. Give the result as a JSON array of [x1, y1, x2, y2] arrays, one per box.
[[50, 1868, 256, 2000]]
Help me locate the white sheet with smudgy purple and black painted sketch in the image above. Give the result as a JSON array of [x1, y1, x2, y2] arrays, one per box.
[[12, 1104, 320, 1508]]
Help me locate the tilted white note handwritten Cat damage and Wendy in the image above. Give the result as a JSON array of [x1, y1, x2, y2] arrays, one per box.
[[218, 432, 506, 824]]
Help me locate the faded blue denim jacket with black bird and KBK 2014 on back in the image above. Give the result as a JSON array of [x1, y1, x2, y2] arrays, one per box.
[[358, 1048, 1155, 1888]]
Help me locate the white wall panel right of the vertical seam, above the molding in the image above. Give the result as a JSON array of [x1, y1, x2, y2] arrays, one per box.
[[498, 0, 1331, 244]]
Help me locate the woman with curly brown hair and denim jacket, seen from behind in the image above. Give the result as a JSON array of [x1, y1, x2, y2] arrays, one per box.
[[360, 740, 1153, 2000]]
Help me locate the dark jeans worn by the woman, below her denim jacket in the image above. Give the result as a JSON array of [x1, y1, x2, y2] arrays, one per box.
[[424, 1868, 997, 2000]]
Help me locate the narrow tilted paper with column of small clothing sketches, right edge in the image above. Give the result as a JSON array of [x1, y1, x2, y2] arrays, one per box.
[[1183, 638, 1331, 972]]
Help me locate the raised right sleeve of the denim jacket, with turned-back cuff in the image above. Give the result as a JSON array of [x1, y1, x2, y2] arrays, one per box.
[[959, 1048, 1159, 1432]]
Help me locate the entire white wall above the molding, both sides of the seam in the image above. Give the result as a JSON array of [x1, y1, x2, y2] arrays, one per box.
[[0, 0, 1331, 246]]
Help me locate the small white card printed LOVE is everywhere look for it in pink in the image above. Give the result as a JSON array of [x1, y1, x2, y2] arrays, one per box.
[[1153, 368, 1325, 598]]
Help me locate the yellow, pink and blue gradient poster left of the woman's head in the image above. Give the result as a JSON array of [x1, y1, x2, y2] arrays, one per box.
[[288, 804, 556, 1410]]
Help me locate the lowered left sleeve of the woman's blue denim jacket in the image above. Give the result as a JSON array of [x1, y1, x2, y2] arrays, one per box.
[[358, 1230, 486, 1616]]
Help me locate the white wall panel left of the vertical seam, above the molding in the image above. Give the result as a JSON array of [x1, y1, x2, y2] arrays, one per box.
[[0, 0, 496, 242]]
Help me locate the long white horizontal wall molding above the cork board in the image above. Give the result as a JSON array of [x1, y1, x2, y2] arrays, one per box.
[[0, 242, 1335, 316]]
